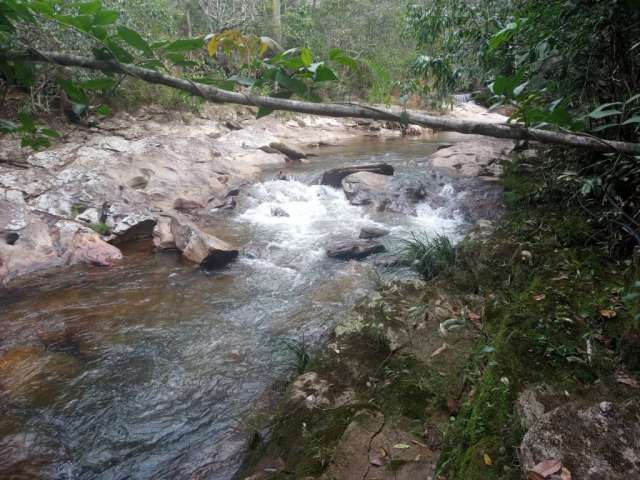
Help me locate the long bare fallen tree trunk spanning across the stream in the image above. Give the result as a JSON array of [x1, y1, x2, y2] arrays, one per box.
[[0, 52, 640, 155]]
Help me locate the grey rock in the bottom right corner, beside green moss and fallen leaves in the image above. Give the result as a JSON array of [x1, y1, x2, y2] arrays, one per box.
[[520, 397, 640, 480]]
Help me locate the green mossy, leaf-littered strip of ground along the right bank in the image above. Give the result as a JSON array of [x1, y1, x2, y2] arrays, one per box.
[[440, 159, 638, 480]]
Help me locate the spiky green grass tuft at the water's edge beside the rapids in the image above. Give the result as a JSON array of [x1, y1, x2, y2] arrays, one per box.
[[402, 233, 457, 280]]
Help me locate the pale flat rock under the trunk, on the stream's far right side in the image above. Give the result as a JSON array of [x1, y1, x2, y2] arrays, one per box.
[[431, 138, 513, 177]]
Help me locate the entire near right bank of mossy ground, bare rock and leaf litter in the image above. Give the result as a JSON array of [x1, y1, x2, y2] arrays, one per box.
[[239, 151, 640, 480]]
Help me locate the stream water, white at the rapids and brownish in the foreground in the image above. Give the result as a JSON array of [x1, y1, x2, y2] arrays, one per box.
[[0, 133, 465, 480]]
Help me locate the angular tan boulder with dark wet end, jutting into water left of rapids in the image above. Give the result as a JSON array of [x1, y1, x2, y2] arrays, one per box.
[[171, 217, 239, 270]]
